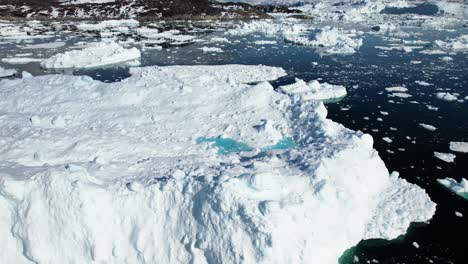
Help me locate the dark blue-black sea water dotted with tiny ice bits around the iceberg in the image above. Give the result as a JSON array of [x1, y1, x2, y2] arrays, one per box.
[[0, 21, 468, 264]]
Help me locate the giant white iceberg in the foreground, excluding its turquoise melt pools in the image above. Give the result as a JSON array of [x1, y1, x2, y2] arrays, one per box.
[[0, 65, 435, 264]]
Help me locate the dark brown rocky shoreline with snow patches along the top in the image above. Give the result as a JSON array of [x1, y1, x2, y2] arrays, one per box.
[[0, 0, 297, 21]]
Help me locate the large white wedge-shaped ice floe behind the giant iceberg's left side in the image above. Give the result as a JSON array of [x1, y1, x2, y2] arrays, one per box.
[[41, 41, 141, 68]]
